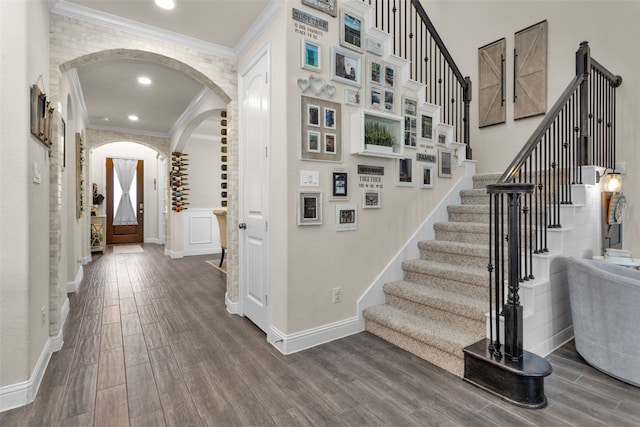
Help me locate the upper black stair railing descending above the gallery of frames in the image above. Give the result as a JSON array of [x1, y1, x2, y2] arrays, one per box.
[[362, 0, 472, 159]]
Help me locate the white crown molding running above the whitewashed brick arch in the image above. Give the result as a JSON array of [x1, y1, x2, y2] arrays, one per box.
[[47, 0, 236, 59]]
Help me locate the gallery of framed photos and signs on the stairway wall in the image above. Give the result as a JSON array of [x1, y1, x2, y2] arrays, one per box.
[[292, 0, 455, 231]]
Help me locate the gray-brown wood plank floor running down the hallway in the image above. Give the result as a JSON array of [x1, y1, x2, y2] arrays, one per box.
[[0, 245, 640, 427]]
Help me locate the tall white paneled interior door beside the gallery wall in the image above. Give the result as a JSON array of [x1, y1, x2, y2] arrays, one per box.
[[238, 48, 271, 333]]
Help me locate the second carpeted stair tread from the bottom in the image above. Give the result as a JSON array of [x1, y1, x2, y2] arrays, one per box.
[[384, 280, 489, 321]]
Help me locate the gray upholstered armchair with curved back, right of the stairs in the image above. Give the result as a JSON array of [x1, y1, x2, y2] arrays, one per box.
[[567, 258, 640, 387]]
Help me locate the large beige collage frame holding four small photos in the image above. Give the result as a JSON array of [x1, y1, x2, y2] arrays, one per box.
[[300, 96, 342, 162]]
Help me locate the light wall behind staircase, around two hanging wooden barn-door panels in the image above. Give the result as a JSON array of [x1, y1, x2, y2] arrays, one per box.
[[422, 0, 640, 253]]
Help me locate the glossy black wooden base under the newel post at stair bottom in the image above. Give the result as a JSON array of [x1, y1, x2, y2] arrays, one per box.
[[462, 339, 551, 409]]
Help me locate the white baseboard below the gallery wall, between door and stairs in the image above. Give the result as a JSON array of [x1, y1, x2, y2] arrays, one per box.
[[269, 316, 364, 354]]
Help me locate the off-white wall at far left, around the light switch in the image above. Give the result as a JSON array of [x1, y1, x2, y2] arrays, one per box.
[[0, 2, 50, 390]]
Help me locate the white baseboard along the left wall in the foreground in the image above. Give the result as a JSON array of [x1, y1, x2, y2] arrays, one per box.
[[0, 298, 69, 412]]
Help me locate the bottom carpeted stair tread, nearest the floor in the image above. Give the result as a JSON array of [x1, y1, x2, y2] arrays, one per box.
[[364, 304, 481, 358]]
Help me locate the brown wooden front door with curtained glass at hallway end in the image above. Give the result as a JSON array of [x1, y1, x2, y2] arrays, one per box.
[[107, 157, 144, 244]]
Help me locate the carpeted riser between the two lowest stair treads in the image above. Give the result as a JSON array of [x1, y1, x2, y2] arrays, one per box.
[[385, 294, 487, 337]]
